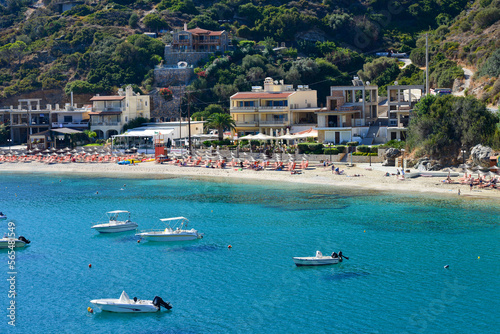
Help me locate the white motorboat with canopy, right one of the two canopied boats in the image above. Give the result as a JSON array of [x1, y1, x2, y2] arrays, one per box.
[[136, 217, 204, 241]]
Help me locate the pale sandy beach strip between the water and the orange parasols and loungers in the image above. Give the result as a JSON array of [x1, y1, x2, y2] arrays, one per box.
[[0, 161, 500, 198]]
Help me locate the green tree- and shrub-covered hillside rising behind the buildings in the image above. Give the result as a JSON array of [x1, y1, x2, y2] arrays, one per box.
[[0, 0, 499, 104]]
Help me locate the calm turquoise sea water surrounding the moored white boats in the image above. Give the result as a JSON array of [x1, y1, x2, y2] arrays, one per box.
[[0, 173, 500, 334]]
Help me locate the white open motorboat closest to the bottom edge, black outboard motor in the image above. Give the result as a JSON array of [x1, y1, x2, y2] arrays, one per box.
[[90, 291, 172, 313]]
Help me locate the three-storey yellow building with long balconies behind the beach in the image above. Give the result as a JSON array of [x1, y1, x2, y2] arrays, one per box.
[[230, 78, 319, 137]]
